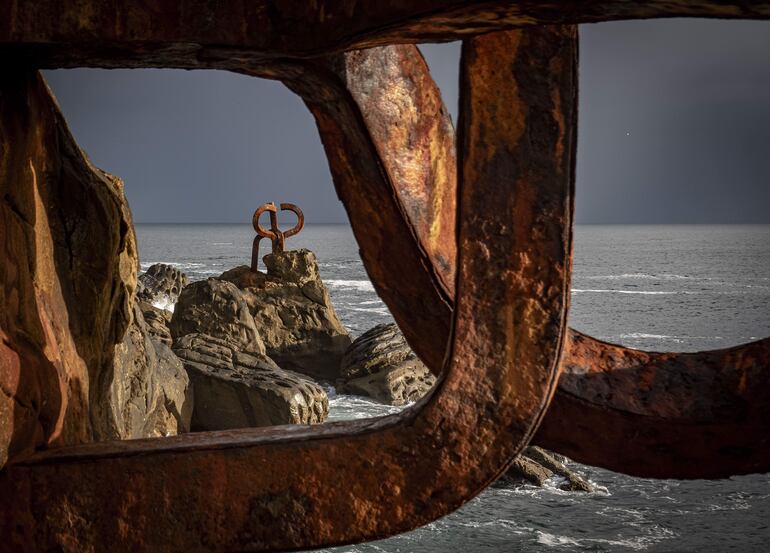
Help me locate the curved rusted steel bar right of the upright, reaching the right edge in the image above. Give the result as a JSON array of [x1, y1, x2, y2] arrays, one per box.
[[534, 330, 770, 478]]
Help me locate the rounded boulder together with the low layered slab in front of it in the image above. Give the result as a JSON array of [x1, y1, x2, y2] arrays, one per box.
[[170, 278, 329, 430]]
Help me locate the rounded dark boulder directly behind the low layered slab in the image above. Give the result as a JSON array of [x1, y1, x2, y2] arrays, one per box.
[[169, 278, 265, 355]]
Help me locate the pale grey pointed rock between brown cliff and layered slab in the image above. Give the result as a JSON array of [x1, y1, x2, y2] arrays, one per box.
[[92, 305, 193, 440]]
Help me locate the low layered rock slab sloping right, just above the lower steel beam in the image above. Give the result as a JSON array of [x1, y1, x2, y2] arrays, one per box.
[[174, 334, 329, 431]]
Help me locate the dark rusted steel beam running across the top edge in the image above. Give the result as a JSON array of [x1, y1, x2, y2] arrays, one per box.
[[0, 0, 770, 67]]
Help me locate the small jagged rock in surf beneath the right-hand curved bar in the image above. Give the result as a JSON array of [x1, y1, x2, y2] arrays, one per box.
[[501, 446, 594, 492]]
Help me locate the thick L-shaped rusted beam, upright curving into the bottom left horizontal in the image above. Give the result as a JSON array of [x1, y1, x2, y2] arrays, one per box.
[[0, 27, 576, 551]]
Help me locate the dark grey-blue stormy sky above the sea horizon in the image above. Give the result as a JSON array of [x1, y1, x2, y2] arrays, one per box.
[[44, 19, 770, 224]]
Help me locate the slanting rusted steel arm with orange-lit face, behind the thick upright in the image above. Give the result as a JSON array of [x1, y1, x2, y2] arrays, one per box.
[[276, 49, 457, 369]]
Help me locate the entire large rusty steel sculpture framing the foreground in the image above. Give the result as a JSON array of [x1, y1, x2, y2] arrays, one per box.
[[0, 0, 770, 551]]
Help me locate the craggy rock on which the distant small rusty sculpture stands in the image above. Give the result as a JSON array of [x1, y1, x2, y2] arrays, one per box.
[[221, 249, 351, 381]]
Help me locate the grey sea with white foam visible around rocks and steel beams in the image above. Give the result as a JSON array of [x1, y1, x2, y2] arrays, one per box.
[[136, 224, 770, 553]]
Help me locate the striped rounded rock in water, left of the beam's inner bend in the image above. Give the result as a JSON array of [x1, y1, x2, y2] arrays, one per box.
[[340, 323, 436, 405]]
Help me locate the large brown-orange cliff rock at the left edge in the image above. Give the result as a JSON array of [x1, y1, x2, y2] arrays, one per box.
[[0, 69, 138, 467]]
